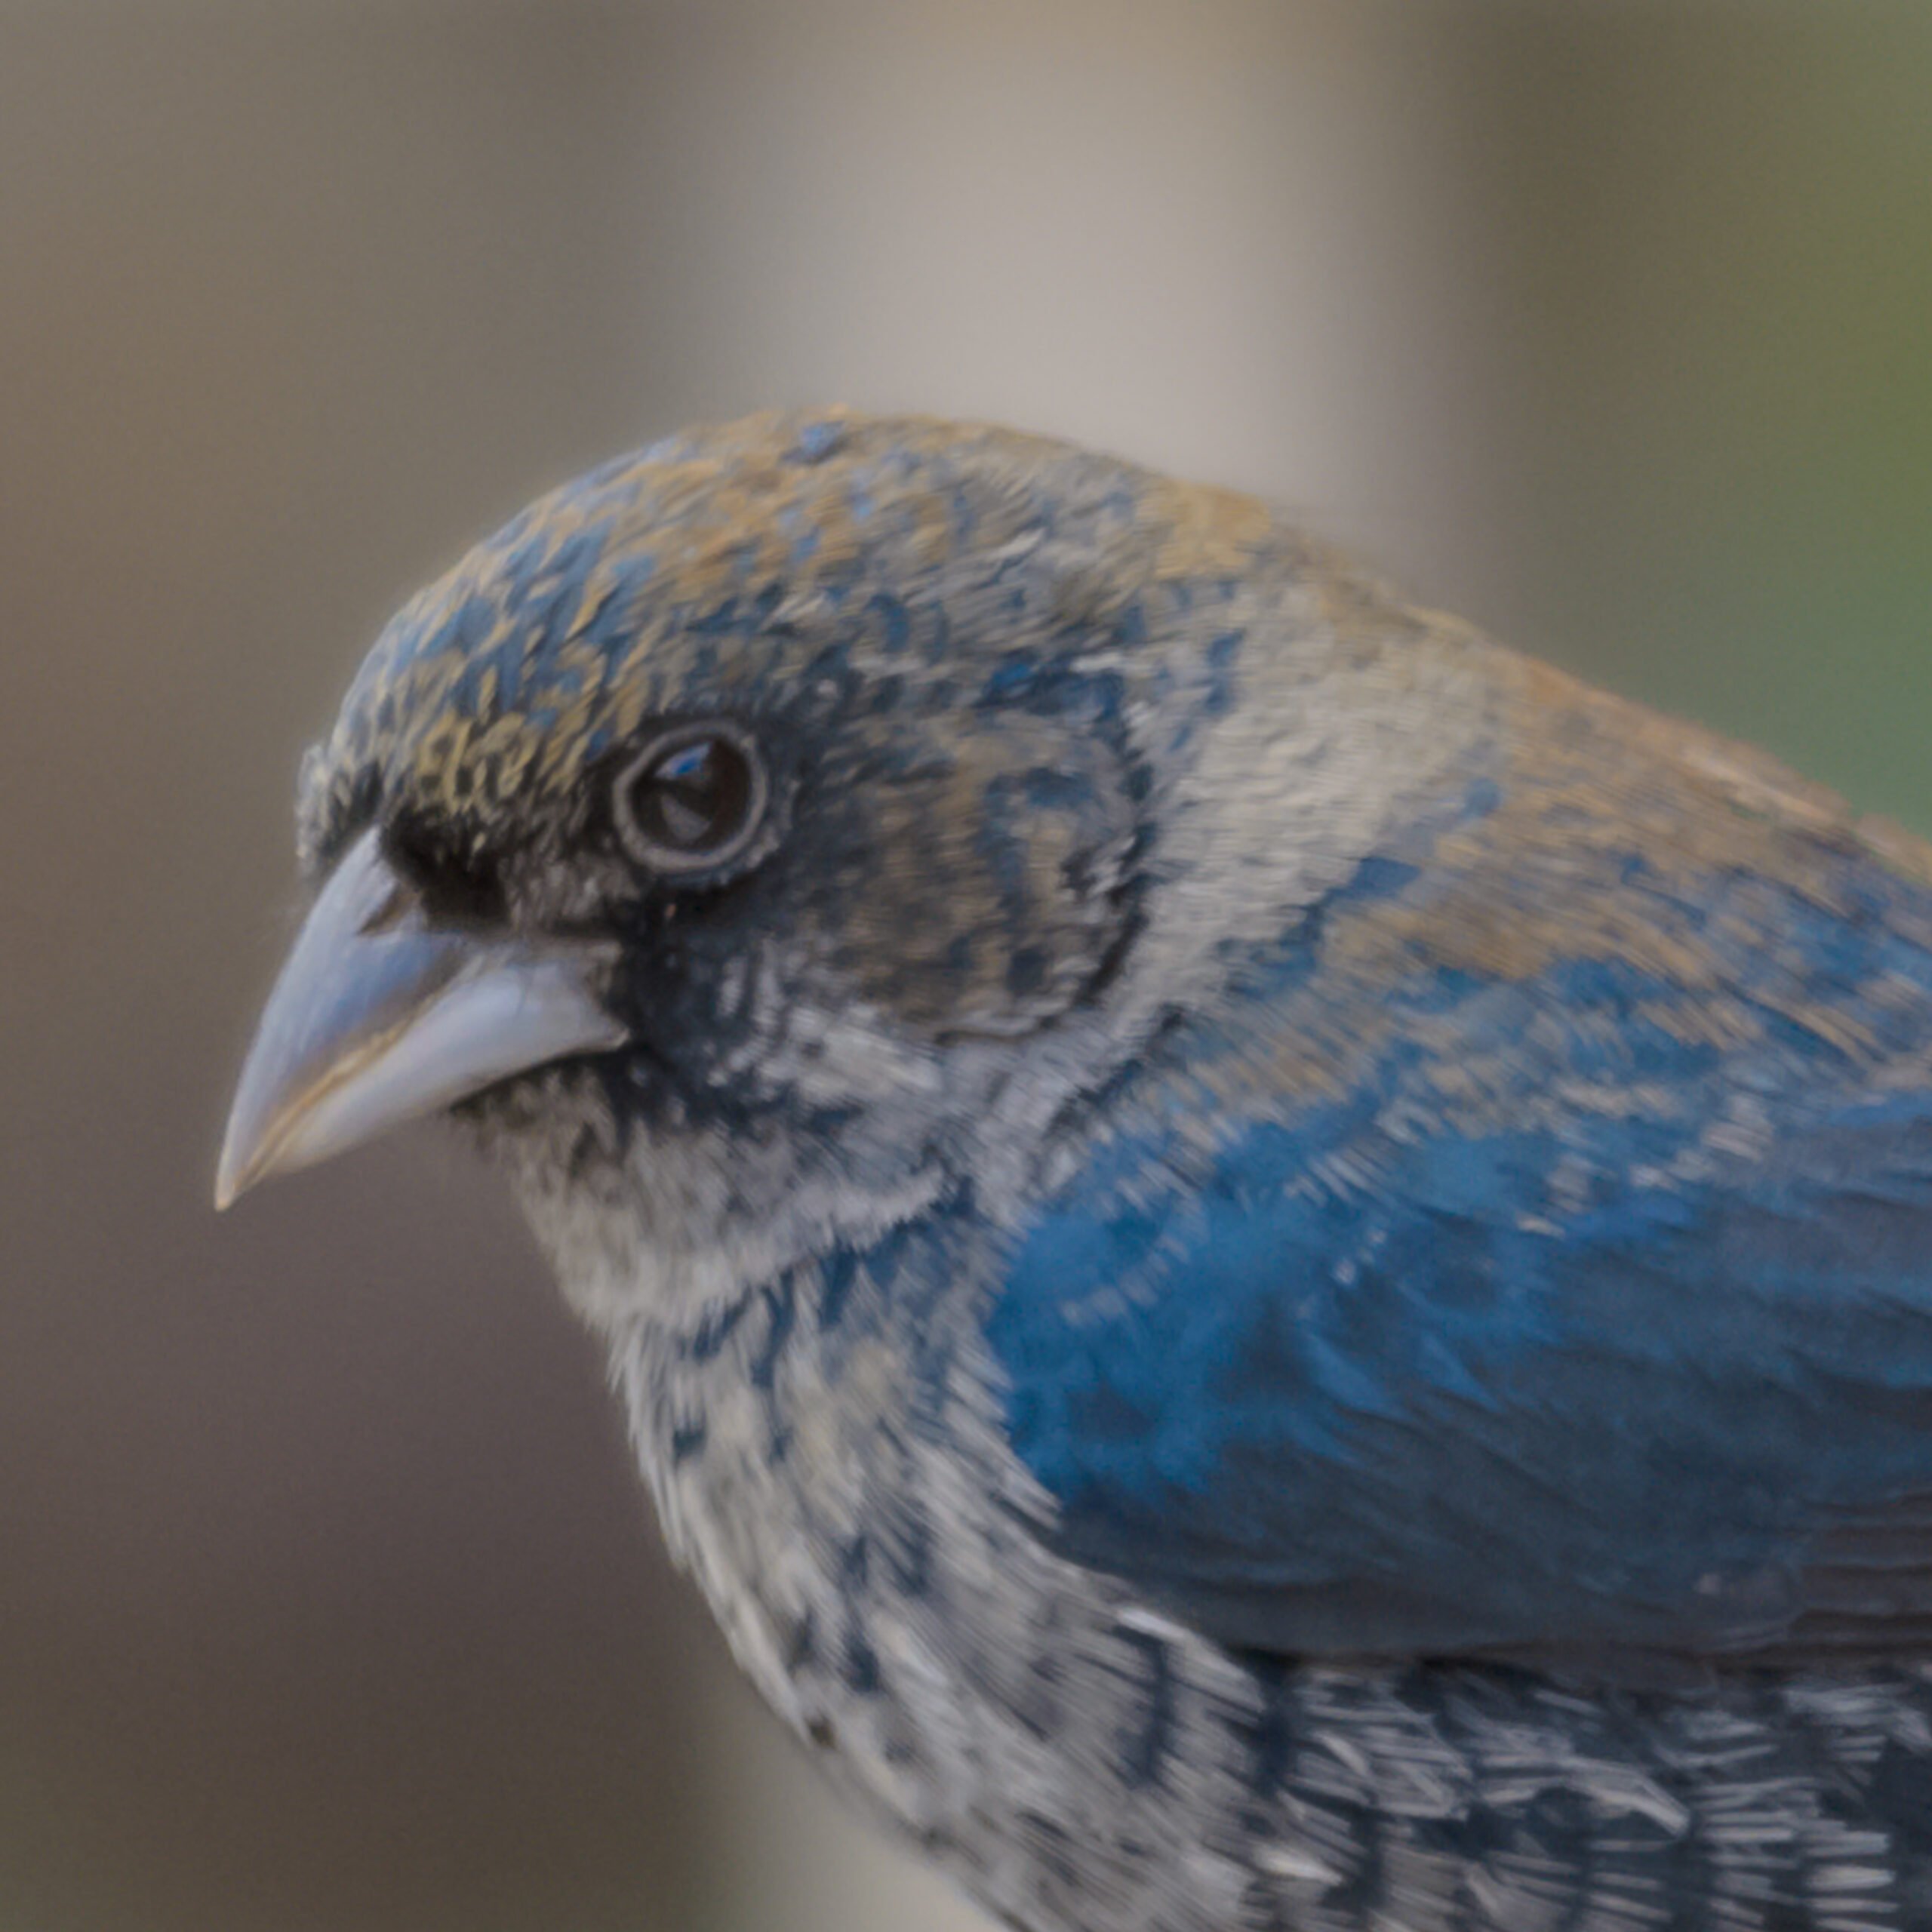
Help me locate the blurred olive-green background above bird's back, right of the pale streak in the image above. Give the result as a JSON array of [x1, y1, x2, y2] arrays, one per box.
[[1459, 0, 1932, 829]]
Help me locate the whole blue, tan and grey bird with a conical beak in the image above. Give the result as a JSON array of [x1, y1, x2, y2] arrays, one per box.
[[217, 408, 1932, 1932]]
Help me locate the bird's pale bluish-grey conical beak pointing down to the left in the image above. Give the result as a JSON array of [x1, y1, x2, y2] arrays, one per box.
[[214, 831, 626, 1208]]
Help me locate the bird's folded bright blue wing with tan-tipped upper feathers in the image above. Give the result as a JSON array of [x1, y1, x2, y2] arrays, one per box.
[[986, 699, 1932, 1662]]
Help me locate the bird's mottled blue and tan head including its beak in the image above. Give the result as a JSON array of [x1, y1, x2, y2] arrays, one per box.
[[218, 414, 1453, 1314]]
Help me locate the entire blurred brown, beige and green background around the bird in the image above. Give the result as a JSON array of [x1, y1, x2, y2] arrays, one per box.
[[0, 0, 1932, 1932]]
